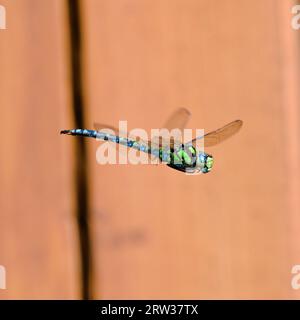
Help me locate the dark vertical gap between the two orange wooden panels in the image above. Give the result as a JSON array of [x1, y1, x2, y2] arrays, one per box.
[[67, 0, 93, 299]]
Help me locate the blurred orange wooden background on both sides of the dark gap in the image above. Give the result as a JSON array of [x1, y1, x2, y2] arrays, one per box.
[[0, 0, 300, 299]]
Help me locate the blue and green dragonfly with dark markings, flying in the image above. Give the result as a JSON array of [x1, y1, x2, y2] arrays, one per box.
[[60, 108, 243, 175]]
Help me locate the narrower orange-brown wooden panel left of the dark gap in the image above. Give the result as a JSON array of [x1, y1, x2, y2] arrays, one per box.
[[0, 0, 79, 299]]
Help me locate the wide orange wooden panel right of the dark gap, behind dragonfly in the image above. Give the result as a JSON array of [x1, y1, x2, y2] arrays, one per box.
[[83, 0, 300, 298]]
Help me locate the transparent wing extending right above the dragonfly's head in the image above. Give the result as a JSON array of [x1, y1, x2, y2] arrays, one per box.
[[192, 120, 243, 147]]
